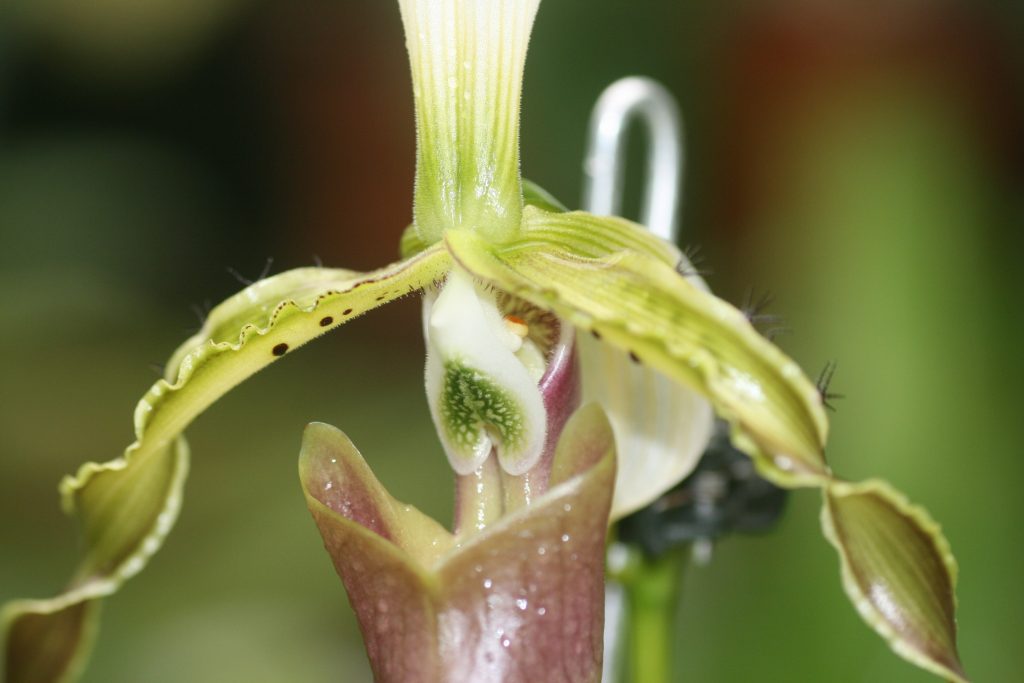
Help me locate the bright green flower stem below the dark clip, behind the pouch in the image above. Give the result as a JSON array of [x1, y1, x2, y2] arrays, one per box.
[[620, 546, 690, 683]]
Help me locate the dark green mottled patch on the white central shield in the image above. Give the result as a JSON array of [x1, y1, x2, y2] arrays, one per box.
[[441, 360, 523, 451]]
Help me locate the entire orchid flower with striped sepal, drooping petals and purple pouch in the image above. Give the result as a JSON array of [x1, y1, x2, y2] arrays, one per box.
[[3, 0, 966, 683]]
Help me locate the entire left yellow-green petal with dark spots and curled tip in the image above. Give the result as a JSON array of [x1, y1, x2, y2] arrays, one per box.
[[0, 246, 450, 683]]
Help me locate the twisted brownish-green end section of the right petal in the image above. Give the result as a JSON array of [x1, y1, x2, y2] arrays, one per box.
[[821, 480, 967, 683]]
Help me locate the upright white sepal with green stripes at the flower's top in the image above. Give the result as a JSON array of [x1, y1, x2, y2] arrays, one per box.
[[398, 0, 540, 245]]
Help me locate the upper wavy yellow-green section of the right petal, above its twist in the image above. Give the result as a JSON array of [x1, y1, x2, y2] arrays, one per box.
[[445, 216, 829, 486]]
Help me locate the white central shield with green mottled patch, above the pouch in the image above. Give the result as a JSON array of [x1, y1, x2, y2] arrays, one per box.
[[424, 268, 547, 475]]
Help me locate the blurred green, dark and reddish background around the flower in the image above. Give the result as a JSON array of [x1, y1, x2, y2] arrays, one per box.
[[0, 0, 1024, 683]]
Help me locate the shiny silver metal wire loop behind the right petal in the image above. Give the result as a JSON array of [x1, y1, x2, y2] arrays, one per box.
[[583, 76, 683, 243]]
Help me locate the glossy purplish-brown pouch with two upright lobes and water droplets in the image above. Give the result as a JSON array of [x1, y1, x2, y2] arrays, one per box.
[[299, 405, 614, 683]]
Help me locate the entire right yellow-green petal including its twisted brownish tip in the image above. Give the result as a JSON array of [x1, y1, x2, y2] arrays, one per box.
[[445, 208, 967, 683]]
